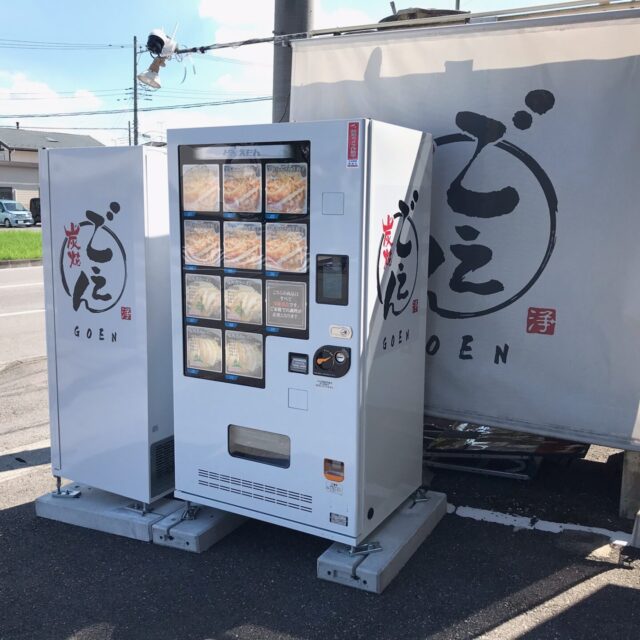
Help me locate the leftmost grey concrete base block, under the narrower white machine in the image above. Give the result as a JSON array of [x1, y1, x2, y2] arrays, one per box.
[[36, 482, 184, 542]]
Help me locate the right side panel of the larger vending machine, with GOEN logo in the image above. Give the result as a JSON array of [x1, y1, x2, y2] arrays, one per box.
[[363, 121, 432, 534]]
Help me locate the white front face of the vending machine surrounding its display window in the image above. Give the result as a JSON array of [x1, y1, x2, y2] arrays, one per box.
[[169, 120, 365, 539]]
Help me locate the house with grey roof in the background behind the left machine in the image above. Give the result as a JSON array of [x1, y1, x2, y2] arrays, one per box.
[[0, 127, 103, 209]]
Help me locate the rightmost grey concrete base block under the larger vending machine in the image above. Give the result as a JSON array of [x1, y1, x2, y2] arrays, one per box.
[[318, 491, 447, 593]]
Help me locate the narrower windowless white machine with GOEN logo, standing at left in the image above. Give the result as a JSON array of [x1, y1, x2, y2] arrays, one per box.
[[40, 147, 173, 503]]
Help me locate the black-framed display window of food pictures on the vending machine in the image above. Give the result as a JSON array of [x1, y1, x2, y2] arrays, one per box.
[[178, 141, 311, 387]]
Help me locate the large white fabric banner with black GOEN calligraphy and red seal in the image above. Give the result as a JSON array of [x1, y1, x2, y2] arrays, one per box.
[[291, 10, 640, 449]]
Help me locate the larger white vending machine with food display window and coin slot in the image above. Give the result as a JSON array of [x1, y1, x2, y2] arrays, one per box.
[[168, 119, 432, 545]]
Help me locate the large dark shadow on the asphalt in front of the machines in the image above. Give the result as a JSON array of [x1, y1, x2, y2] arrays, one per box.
[[0, 503, 639, 640]]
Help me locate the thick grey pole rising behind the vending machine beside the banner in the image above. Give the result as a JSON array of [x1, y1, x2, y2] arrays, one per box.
[[272, 0, 313, 122]]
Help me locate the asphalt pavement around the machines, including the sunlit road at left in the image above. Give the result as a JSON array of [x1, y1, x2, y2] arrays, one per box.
[[0, 262, 640, 640]]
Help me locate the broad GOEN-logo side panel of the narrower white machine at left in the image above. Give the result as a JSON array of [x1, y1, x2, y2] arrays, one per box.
[[47, 148, 149, 501]]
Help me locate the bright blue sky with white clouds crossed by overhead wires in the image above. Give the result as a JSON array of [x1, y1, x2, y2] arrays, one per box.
[[0, 0, 560, 144]]
